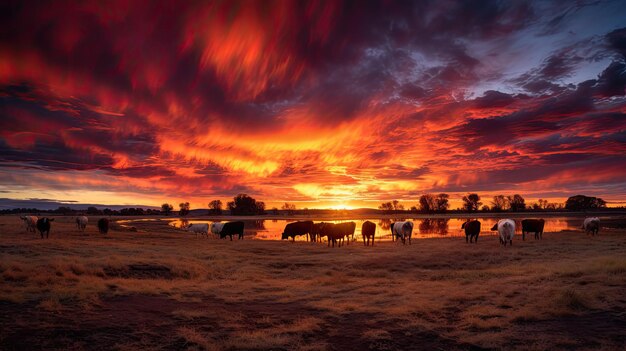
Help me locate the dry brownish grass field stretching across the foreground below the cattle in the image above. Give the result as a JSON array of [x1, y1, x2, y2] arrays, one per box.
[[0, 217, 626, 350]]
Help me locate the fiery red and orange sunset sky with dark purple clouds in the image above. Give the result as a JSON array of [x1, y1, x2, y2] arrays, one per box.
[[0, 1, 626, 208]]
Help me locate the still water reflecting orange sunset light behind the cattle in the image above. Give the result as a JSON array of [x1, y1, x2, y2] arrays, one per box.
[[169, 217, 583, 241]]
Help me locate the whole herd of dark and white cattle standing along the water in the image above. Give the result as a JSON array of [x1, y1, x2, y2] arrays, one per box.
[[20, 216, 600, 247]]
